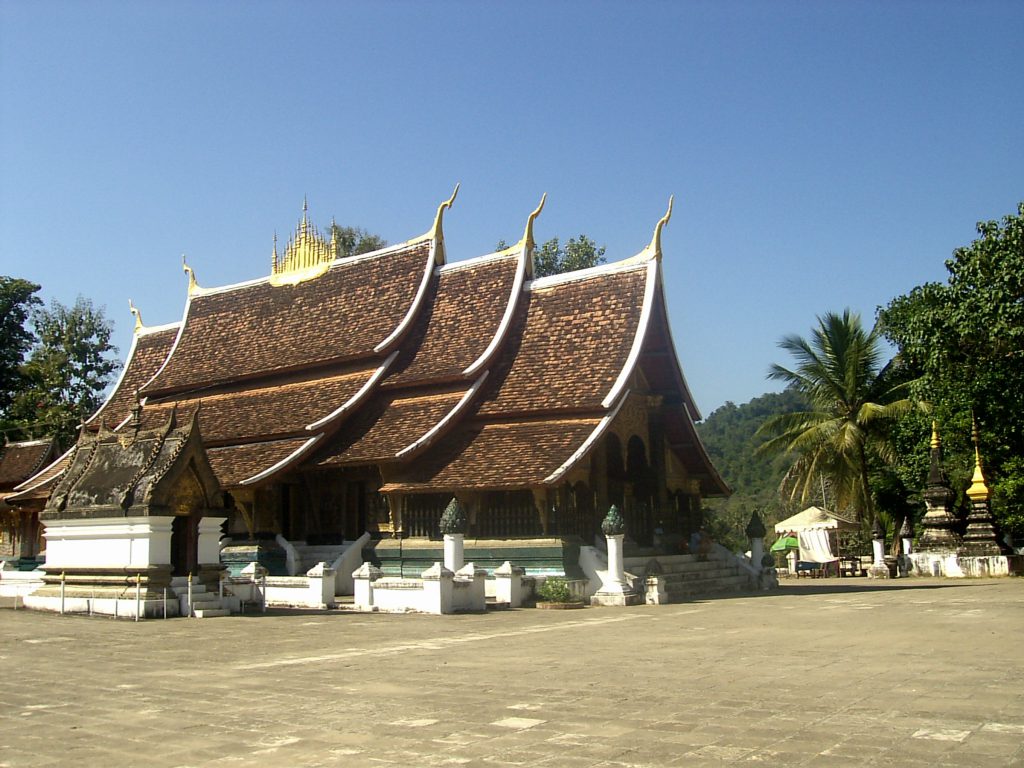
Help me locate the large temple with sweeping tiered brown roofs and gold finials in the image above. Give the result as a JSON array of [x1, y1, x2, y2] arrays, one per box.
[[9, 187, 729, 589]]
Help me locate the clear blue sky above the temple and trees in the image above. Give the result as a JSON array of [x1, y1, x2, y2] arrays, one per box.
[[0, 0, 1024, 415]]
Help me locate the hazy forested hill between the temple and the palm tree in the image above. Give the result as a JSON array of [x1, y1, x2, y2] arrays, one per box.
[[697, 389, 807, 549]]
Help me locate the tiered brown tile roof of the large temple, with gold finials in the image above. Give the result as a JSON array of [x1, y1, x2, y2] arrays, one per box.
[[9, 196, 728, 495]]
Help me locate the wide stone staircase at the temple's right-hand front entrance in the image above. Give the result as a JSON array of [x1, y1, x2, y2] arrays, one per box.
[[626, 553, 750, 604]]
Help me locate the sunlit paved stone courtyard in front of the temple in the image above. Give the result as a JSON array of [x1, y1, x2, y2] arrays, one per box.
[[0, 579, 1024, 768]]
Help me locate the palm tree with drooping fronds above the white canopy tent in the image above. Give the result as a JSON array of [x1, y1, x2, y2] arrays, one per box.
[[758, 309, 910, 522]]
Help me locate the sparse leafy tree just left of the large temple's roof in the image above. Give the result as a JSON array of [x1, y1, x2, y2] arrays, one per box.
[[12, 297, 120, 444]]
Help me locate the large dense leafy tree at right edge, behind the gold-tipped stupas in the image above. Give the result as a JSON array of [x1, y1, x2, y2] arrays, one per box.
[[879, 203, 1024, 537]]
